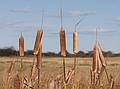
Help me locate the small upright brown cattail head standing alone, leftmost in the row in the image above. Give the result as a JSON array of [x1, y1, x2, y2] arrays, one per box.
[[19, 33, 24, 57]]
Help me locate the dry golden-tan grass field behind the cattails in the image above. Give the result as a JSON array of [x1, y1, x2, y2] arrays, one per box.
[[0, 57, 120, 89]]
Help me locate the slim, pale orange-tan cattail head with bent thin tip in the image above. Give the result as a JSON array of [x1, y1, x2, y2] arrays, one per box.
[[73, 31, 78, 54]]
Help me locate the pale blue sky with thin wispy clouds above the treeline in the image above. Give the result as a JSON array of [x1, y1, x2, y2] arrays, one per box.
[[0, 0, 120, 53]]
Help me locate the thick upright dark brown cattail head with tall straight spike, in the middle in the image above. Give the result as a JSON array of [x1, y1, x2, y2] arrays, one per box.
[[60, 27, 66, 56]]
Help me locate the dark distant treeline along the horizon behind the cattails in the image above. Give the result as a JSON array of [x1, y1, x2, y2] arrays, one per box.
[[0, 47, 120, 57]]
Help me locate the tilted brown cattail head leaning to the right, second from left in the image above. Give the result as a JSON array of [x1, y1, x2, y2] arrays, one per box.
[[34, 29, 43, 55]]
